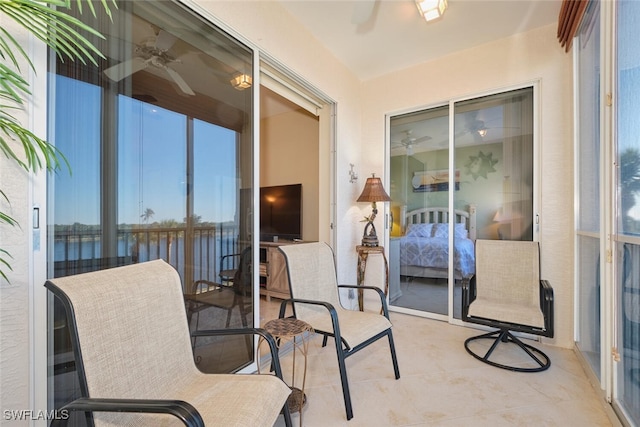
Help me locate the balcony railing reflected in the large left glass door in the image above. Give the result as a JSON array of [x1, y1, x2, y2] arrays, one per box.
[[53, 224, 242, 283]]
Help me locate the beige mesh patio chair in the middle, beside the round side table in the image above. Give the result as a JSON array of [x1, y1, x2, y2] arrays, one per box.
[[279, 243, 400, 420]]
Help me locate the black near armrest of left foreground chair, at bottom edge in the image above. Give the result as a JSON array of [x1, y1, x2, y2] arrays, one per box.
[[51, 397, 204, 427]]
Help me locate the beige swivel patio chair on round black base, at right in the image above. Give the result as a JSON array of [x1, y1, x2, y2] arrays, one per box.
[[462, 240, 553, 372]]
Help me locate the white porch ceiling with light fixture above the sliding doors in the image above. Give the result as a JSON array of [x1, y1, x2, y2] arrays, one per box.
[[280, 0, 562, 80]]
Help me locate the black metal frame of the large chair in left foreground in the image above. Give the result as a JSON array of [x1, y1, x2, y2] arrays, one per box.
[[45, 281, 292, 427]]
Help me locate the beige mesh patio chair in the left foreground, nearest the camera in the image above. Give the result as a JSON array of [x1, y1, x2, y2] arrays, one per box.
[[45, 260, 291, 427]]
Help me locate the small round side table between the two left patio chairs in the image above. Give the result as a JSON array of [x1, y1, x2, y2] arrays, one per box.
[[258, 317, 313, 426]]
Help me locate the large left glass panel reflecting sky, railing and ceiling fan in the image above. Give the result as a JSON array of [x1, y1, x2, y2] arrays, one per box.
[[48, 1, 254, 425]]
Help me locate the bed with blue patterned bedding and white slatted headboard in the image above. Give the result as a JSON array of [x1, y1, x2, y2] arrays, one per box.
[[400, 205, 476, 279]]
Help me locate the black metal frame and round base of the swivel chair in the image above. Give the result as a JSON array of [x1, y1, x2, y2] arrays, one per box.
[[462, 270, 554, 372]]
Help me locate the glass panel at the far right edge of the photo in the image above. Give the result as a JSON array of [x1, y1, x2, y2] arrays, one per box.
[[613, 1, 640, 424]]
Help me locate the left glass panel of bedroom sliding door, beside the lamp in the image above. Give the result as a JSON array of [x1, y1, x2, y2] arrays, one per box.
[[389, 106, 449, 316]]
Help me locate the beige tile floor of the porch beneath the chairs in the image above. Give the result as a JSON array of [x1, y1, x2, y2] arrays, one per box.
[[261, 300, 612, 427]]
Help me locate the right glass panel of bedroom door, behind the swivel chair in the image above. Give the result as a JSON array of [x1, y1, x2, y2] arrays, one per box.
[[453, 87, 534, 319]]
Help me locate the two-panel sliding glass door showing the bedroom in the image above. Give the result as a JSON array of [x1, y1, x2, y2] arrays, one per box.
[[389, 86, 536, 319]]
